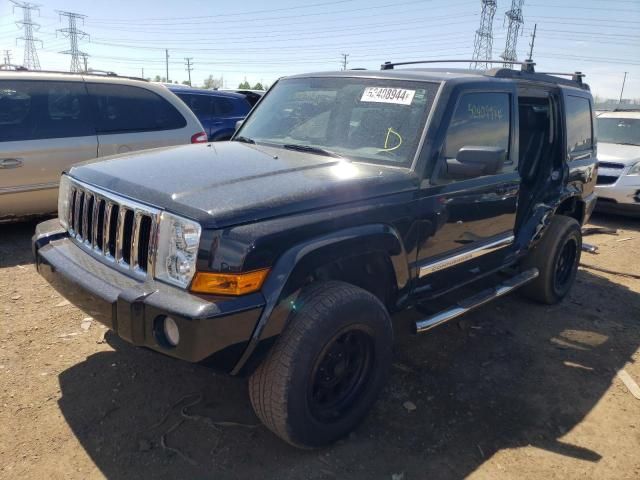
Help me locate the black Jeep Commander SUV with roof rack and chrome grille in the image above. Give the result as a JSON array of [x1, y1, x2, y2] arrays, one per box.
[[34, 62, 597, 447]]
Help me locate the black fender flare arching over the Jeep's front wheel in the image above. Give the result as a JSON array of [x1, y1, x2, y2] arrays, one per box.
[[231, 224, 409, 375]]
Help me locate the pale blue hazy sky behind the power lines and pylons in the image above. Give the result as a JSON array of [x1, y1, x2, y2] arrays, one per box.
[[0, 0, 640, 98]]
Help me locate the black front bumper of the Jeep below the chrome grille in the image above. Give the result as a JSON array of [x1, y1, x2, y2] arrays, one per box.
[[33, 219, 264, 372]]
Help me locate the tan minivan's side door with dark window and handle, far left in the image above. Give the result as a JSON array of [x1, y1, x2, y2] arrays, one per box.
[[0, 78, 98, 218]]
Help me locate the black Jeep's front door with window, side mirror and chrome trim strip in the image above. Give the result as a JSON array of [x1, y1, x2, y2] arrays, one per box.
[[416, 88, 520, 293]]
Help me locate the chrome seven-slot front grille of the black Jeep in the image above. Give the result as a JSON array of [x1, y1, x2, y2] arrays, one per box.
[[67, 180, 159, 278]]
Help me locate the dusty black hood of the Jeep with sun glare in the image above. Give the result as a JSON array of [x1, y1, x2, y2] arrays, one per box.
[[69, 142, 417, 228]]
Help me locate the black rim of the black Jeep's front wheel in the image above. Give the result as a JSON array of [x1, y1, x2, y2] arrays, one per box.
[[308, 329, 374, 422]]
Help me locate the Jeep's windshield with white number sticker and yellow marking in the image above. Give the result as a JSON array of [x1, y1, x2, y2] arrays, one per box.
[[238, 77, 438, 167]]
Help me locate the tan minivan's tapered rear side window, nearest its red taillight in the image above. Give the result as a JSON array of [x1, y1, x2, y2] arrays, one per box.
[[87, 83, 187, 134]]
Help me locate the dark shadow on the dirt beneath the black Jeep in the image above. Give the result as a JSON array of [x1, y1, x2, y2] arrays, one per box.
[[59, 270, 640, 479]]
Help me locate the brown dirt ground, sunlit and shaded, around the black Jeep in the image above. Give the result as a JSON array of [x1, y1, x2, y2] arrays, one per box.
[[0, 217, 640, 480]]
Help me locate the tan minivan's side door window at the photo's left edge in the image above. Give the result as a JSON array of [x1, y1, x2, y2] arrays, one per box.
[[0, 80, 96, 142]]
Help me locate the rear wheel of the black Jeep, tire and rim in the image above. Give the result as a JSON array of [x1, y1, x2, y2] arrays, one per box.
[[521, 215, 582, 305]]
